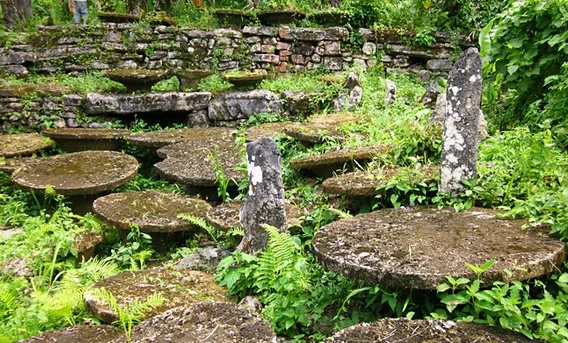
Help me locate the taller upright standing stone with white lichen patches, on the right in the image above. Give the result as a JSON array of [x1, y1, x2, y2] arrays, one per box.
[[440, 48, 482, 195]]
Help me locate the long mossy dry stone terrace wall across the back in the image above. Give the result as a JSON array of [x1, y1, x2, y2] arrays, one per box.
[[0, 23, 468, 75]]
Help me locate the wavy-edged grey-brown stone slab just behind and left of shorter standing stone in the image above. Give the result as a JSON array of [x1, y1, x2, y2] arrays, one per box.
[[154, 142, 245, 187]]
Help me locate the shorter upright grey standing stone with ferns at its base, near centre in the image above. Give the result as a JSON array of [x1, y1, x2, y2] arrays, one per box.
[[239, 138, 287, 253]]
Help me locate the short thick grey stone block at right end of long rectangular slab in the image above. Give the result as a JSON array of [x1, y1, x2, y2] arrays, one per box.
[[209, 90, 282, 121]]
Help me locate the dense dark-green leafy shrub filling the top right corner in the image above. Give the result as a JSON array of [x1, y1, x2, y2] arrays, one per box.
[[480, 0, 568, 144]]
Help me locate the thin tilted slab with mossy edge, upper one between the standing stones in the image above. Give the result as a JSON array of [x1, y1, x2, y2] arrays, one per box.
[[290, 146, 390, 176]]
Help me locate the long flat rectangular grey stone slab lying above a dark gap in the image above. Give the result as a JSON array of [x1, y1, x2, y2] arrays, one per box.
[[85, 92, 211, 114]]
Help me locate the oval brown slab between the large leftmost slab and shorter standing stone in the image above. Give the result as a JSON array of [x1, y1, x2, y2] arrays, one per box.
[[93, 191, 211, 232]]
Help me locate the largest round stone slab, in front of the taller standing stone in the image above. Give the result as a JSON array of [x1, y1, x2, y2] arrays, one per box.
[[312, 207, 566, 289]]
